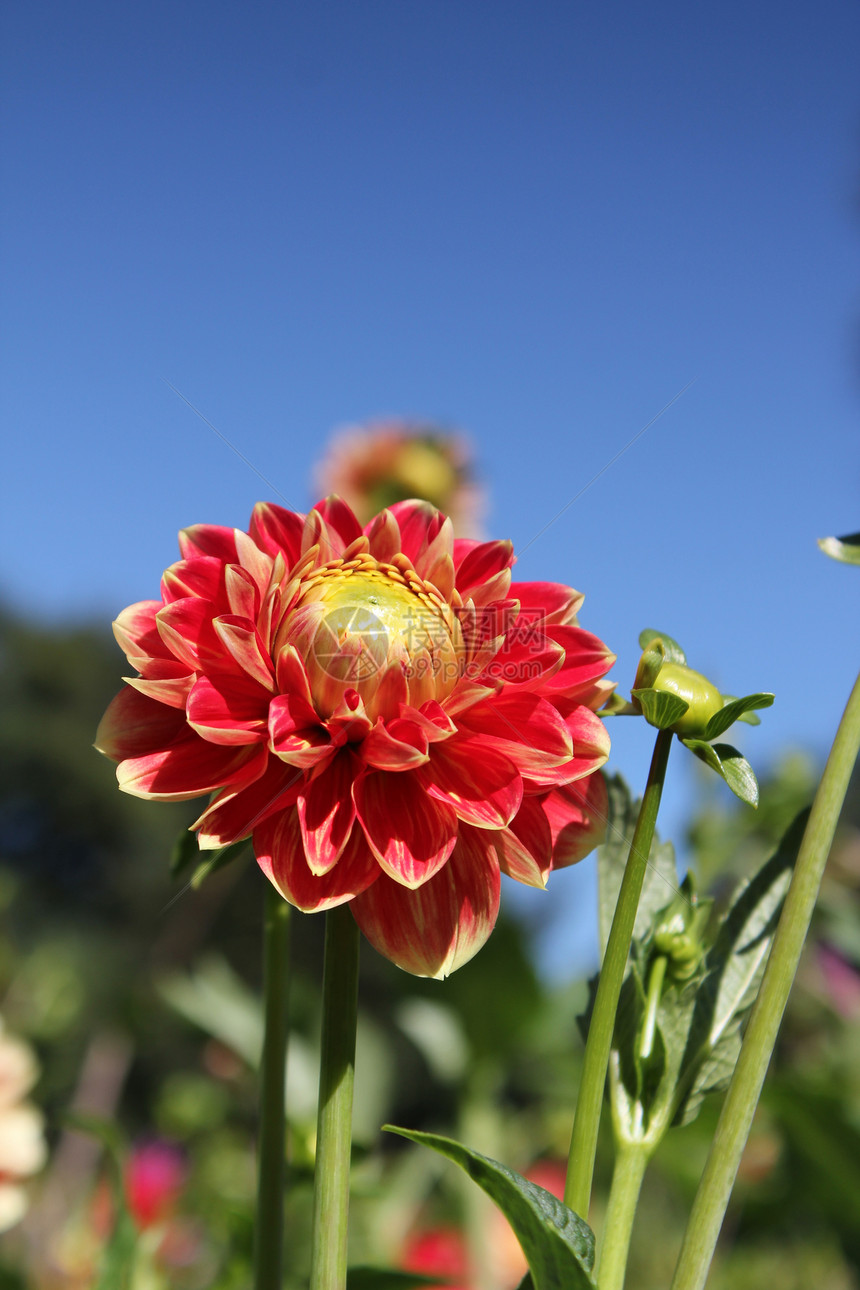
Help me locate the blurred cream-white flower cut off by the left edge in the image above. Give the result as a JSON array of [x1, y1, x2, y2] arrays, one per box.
[[0, 1020, 48, 1232]]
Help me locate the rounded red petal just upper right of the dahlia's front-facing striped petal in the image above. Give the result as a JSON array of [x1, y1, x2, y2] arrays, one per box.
[[418, 738, 522, 828]]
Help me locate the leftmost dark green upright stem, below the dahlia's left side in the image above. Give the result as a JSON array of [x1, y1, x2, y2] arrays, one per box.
[[254, 882, 290, 1290]]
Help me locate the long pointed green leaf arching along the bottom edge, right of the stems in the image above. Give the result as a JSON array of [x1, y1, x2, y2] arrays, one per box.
[[383, 1125, 594, 1290]]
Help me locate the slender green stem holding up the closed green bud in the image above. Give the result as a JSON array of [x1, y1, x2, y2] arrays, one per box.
[[565, 730, 674, 1219]]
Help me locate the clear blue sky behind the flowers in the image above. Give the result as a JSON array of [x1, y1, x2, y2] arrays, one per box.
[[0, 0, 860, 960]]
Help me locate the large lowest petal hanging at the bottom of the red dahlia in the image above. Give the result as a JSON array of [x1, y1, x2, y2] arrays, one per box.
[[352, 826, 500, 977]]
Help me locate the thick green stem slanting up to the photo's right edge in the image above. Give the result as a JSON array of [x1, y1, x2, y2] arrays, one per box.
[[672, 676, 860, 1290]]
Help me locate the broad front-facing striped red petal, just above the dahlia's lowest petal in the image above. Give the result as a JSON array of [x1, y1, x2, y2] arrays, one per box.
[[352, 770, 456, 888]]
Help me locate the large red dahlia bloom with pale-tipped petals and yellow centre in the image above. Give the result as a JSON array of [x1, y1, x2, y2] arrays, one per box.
[[97, 497, 614, 977]]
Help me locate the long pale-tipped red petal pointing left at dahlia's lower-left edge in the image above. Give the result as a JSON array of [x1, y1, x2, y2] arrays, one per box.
[[116, 732, 268, 801]]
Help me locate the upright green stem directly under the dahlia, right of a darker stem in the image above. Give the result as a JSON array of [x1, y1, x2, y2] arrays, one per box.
[[311, 904, 358, 1290]]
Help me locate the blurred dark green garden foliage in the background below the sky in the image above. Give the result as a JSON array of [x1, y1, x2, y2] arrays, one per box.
[[0, 614, 860, 1290]]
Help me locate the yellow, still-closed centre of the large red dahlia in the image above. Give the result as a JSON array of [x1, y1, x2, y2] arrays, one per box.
[[290, 555, 463, 719]]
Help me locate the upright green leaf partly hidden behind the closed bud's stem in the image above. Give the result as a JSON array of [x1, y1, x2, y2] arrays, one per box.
[[597, 775, 679, 952]]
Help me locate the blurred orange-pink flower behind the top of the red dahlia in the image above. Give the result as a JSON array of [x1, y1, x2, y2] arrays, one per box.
[[316, 419, 484, 537]]
